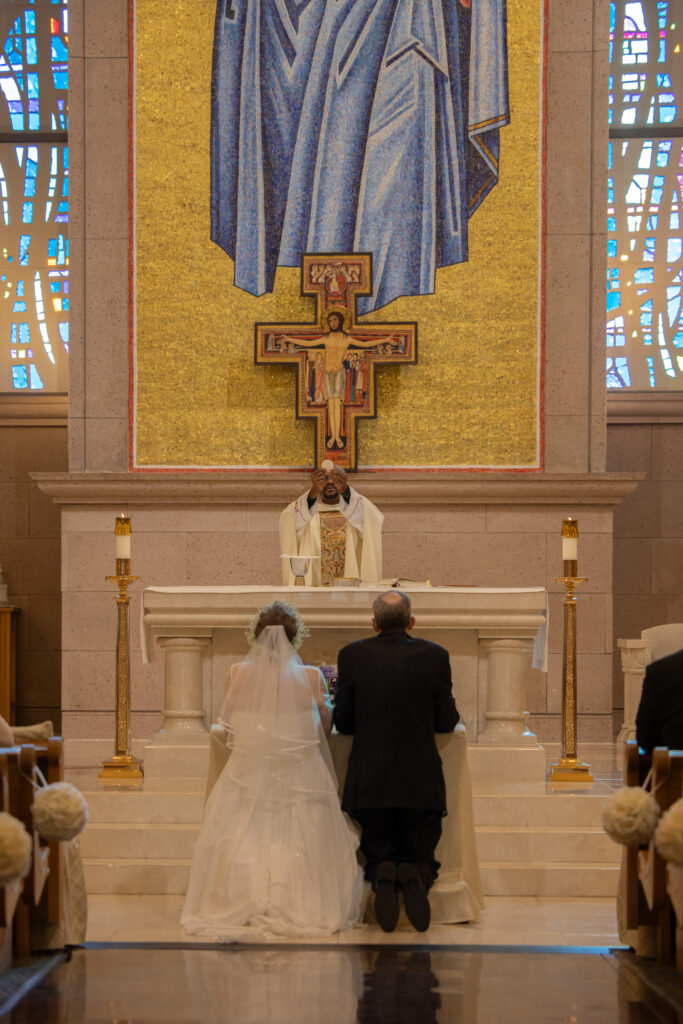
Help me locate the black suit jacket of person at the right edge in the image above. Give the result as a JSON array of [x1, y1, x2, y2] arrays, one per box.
[[636, 650, 683, 751]]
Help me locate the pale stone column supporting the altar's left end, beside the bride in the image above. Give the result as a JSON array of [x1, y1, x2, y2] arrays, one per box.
[[154, 637, 210, 745]]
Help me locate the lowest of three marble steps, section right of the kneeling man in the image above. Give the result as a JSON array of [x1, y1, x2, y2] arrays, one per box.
[[479, 861, 618, 898]]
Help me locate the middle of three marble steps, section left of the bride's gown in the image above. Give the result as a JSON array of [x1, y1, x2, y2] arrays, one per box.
[[81, 821, 200, 860]]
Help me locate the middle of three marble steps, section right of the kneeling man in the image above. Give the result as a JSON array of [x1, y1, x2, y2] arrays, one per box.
[[475, 825, 622, 864]]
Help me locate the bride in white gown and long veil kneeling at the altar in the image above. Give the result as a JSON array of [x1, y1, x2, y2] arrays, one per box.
[[180, 601, 362, 942]]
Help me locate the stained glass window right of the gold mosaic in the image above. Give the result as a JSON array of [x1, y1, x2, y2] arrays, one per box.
[[606, 0, 683, 391]]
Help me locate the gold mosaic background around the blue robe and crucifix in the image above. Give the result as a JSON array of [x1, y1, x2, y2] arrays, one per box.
[[134, 0, 542, 468]]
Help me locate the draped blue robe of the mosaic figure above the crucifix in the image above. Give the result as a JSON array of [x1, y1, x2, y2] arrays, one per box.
[[211, 0, 509, 312]]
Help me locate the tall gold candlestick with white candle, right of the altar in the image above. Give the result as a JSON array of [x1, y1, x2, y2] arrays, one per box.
[[548, 517, 593, 782]]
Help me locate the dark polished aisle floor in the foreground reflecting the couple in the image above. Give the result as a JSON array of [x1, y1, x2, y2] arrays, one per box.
[[5, 946, 683, 1024]]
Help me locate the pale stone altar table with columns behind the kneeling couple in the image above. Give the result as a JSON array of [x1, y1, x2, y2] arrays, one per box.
[[140, 585, 548, 781]]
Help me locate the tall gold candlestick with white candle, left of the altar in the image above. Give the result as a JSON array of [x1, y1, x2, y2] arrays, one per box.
[[99, 513, 142, 788]]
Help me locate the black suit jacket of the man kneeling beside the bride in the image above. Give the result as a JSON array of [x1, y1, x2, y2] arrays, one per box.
[[334, 629, 460, 811]]
